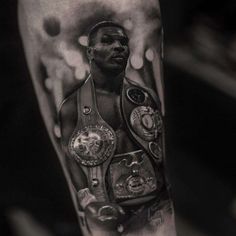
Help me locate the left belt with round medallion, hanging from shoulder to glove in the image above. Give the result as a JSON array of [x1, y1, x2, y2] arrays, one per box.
[[68, 77, 116, 201]]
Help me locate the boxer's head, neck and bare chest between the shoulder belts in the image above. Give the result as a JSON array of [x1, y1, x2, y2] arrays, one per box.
[[87, 26, 137, 153]]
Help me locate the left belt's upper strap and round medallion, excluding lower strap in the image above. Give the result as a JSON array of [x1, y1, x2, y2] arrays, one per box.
[[68, 75, 116, 167]]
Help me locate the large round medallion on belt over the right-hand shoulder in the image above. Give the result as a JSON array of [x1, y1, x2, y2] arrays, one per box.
[[130, 106, 162, 141]]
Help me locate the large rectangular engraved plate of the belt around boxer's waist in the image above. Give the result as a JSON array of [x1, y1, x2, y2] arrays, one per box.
[[110, 151, 160, 200]]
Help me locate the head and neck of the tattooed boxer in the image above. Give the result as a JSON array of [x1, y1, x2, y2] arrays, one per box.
[[87, 26, 129, 93]]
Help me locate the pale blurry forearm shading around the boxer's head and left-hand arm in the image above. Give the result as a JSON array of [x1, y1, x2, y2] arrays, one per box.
[[19, 0, 166, 232]]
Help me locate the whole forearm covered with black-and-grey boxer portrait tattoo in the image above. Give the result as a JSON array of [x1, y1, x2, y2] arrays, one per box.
[[19, 0, 176, 236]]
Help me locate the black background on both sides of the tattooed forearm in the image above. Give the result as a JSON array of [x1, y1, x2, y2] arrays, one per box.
[[0, 0, 236, 236]]
